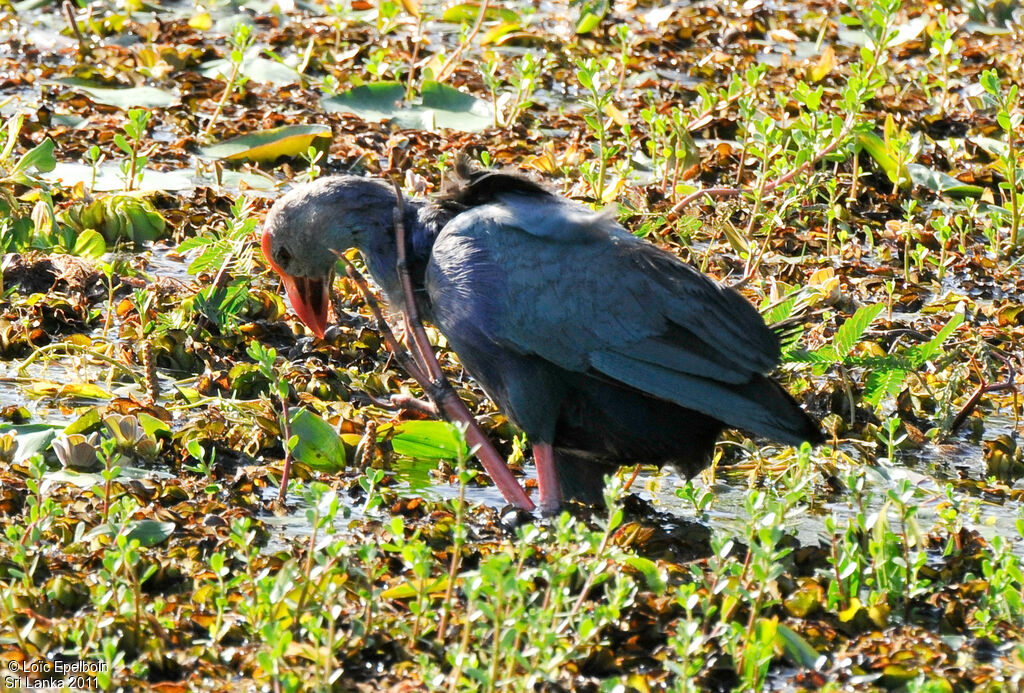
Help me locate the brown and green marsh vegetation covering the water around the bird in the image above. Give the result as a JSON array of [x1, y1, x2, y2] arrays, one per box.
[[0, 0, 1024, 693]]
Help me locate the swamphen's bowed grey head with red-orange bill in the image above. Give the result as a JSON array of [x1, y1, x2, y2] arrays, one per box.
[[262, 176, 395, 336]]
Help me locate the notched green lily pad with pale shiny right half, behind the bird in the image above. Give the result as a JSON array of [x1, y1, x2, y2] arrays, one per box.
[[321, 81, 495, 132]]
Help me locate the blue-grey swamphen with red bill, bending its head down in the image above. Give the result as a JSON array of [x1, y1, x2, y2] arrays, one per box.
[[262, 158, 822, 513]]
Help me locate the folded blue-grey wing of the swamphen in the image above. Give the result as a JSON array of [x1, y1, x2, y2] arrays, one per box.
[[432, 190, 799, 439]]
